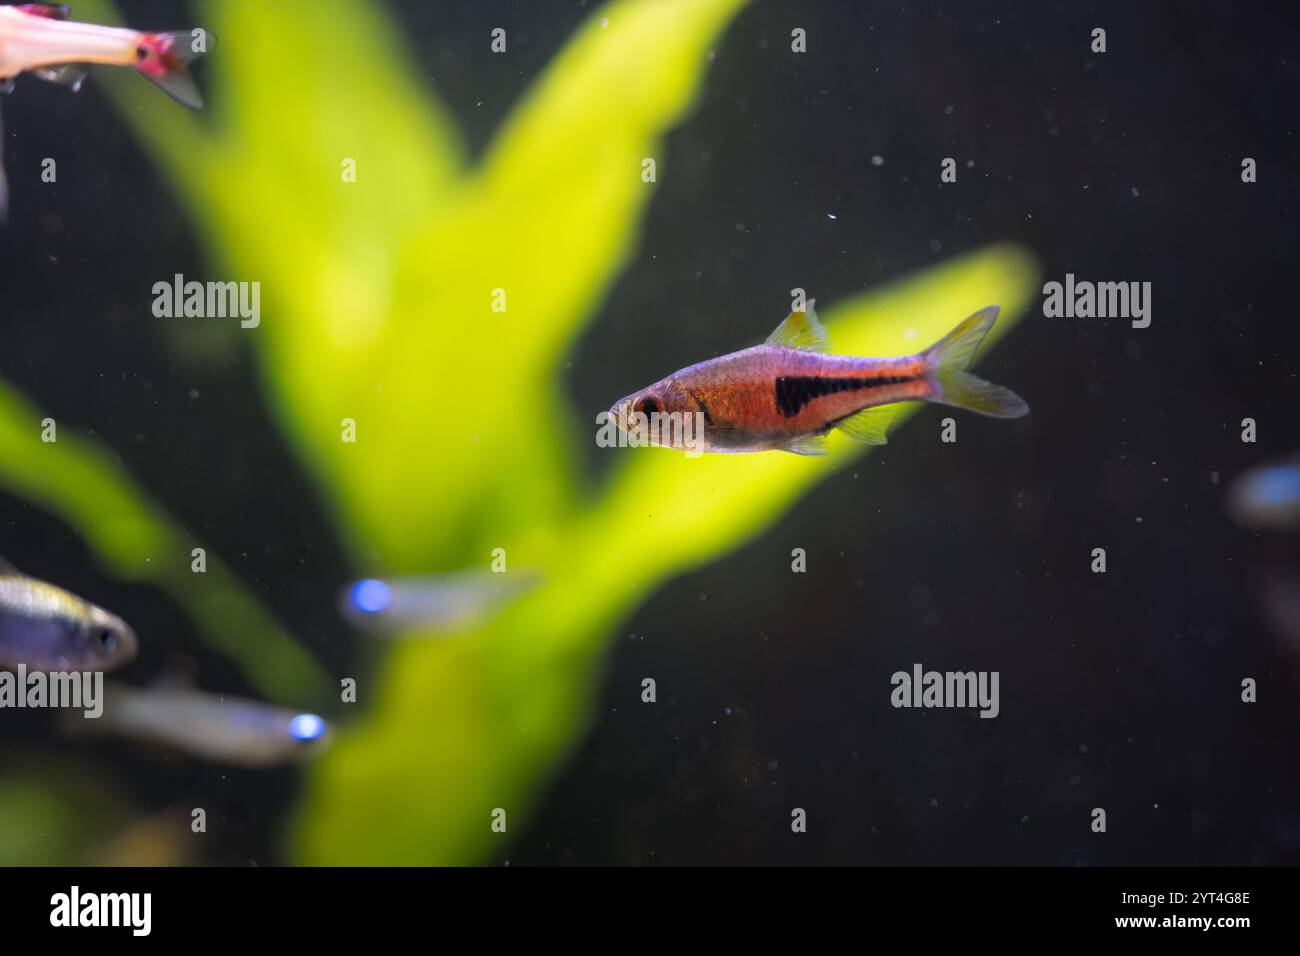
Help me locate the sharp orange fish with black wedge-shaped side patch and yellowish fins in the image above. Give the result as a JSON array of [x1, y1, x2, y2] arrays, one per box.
[[608, 302, 1030, 455]]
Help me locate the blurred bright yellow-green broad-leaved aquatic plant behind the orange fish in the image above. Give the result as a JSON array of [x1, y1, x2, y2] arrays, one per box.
[[0, 0, 1035, 864]]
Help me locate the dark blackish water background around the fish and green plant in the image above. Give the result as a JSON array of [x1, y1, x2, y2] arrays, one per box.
[[0, 0, 1300, 865]]
